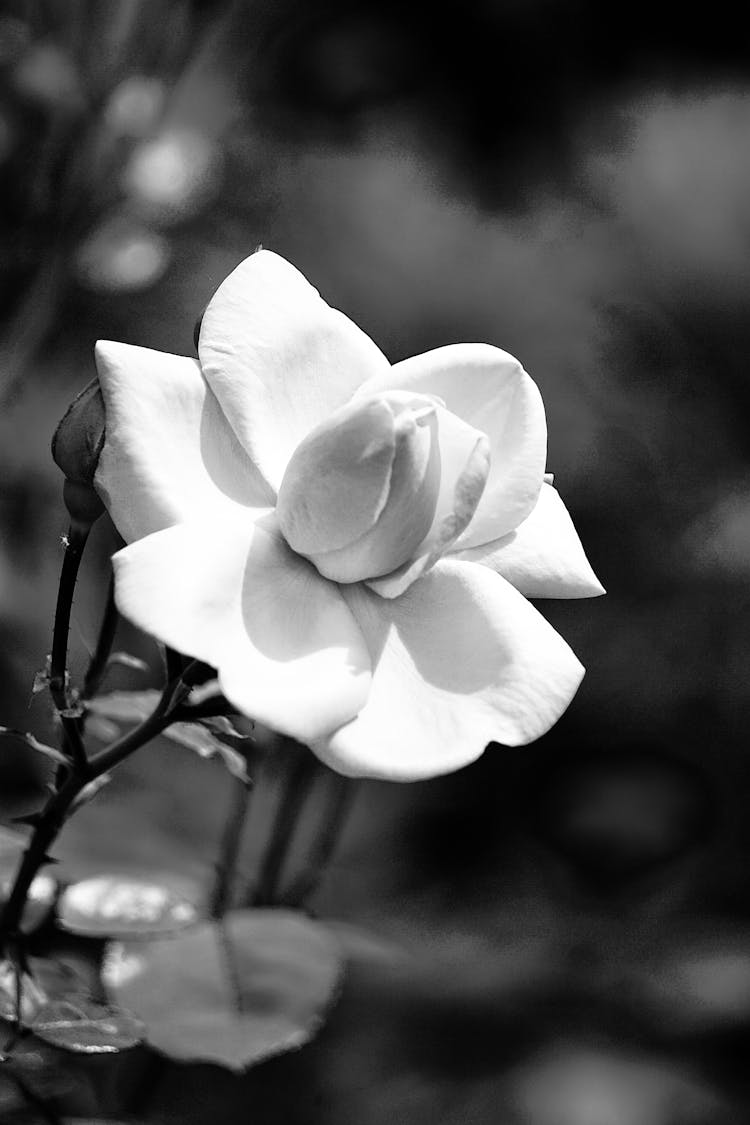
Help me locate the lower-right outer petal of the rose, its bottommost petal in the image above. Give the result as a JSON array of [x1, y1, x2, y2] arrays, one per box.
[[313, 559, 584, 781]]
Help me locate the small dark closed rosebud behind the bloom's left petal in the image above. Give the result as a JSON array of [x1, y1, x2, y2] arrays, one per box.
[[52, 378, 105, 524]]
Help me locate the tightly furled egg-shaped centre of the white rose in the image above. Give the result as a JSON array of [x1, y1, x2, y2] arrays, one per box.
[[277, 392, 440, 583]]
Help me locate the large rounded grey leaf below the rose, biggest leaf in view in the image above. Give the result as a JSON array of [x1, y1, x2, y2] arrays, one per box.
[[102, 910, 342, 1071]]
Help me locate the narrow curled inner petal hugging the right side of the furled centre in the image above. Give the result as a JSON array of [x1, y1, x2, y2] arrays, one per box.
[[368, 406, 490, 597]]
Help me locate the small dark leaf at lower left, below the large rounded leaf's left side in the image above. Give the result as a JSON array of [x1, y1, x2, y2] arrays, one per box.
[[30, 998, 146, 1054]]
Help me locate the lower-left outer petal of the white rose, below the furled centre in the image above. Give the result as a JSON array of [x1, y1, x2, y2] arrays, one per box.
[[114, 518, 370, 741]]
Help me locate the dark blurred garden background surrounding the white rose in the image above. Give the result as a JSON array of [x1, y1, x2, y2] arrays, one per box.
[[0, 0, 750, 1125]]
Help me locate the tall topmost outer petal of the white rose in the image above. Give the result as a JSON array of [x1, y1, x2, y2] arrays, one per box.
[[199, 250, 389, 493]]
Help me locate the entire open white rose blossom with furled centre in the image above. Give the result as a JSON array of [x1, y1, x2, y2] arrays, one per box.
[[89, 251, 603, 781]]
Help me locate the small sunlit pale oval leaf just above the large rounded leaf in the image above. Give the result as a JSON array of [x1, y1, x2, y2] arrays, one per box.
[[57, 875, 198, 938]]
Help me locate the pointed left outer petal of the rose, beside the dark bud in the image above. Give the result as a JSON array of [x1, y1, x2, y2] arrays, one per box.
[[96, 340, 269, 541]]
